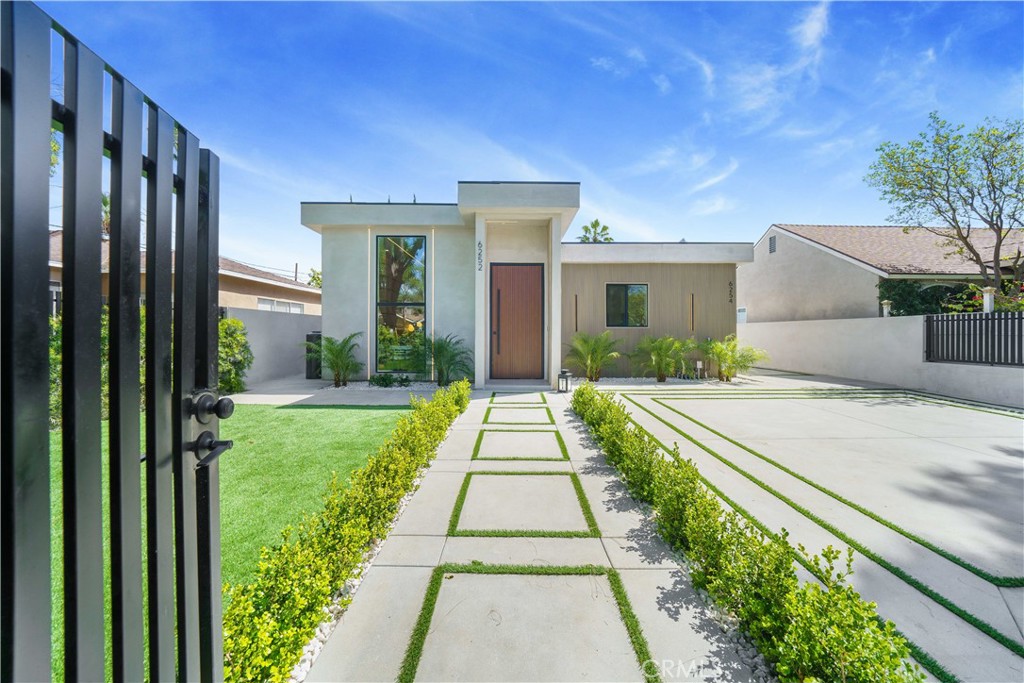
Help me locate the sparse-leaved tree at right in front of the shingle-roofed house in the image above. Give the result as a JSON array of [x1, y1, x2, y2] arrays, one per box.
[[864, 112, 1024, 287]]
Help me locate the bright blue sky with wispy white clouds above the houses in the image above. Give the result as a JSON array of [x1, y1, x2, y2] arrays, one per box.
[[40, 2, 1024, 280]]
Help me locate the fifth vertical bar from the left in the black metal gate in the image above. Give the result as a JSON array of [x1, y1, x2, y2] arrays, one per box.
[[172, 127, 199, 681]]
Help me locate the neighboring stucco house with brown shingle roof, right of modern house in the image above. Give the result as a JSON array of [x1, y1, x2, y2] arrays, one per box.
[[737, 224, 1021, 323]]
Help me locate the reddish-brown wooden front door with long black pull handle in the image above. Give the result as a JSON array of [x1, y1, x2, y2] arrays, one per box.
[[490, 263, 544, 380]]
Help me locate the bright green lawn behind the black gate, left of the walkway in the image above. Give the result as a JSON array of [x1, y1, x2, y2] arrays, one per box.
[[50, 405, 409, 680]]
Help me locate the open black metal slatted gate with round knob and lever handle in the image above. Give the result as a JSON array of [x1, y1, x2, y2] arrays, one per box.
[[0, 1, 231, 681]]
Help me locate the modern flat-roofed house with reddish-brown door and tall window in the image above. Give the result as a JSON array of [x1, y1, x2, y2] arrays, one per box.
[[302, 182, 753, 386]]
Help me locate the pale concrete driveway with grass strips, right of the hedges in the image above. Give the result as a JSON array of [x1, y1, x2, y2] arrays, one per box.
[[614, 377, 1024, 681]]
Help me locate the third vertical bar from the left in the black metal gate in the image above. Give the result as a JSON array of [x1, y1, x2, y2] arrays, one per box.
[[110, 77, 144, 683]]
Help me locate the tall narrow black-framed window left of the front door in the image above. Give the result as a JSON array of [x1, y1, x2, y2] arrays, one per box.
[[376, 236, 427, 375]]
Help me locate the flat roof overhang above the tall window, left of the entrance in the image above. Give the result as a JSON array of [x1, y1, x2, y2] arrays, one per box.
[[301, 202, 466, 232]]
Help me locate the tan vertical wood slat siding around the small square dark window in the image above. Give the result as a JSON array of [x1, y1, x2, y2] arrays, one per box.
[[562, 263, 736, 377]]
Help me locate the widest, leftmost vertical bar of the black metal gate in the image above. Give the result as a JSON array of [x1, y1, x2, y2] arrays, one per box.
[[0, 2, 51, 681]]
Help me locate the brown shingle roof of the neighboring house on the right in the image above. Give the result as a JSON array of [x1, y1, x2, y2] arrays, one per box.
[[772, 223, 1024, 275]]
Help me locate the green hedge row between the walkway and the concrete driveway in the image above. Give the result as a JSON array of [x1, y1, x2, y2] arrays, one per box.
[[572, 383, 925, 683]]
